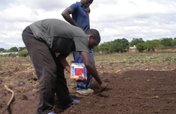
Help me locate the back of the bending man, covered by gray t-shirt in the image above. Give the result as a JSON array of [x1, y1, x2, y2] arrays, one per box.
[[30, 19, 85, 39]]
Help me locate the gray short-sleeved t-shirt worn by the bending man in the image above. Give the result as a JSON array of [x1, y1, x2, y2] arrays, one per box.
[[29, 19, 89, 52]]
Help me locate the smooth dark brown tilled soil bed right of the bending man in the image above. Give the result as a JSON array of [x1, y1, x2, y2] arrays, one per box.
[[62, 71, 176, 114]]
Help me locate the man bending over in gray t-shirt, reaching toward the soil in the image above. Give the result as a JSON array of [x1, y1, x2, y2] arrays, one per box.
[[22, 19, 106, 114]]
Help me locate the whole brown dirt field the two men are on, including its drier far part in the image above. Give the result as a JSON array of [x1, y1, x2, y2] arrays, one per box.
[[0, 55, 176, 114]]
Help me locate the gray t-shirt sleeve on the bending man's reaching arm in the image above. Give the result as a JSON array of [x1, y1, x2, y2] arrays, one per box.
[[73, 37, 89, 52]]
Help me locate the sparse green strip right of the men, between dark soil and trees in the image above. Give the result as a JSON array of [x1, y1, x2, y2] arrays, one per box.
[[95, 53, 176, 71]]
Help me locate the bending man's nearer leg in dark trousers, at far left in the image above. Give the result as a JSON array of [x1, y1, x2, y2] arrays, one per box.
[[22, 28, 57, 114]]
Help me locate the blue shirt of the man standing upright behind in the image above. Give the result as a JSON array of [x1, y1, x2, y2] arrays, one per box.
[[70, 2, 90, 31]]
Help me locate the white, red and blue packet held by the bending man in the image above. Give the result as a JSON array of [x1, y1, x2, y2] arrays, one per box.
[[70, 61, 87, 80]]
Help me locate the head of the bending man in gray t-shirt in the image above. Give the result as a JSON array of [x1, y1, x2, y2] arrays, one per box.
[[86, 29, 101, 49]]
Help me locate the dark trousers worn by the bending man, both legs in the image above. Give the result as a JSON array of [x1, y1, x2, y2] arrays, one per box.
[[22, 27, 72, 114]]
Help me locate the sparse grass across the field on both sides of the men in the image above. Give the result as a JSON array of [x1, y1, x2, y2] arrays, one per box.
[[0, 53, 176, 86]]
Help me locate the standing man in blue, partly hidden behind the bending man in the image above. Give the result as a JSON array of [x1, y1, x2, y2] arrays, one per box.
[[62, 0, 95, 93]]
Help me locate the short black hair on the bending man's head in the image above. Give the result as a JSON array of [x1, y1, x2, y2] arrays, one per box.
[[86, 29, 101, 42]]
